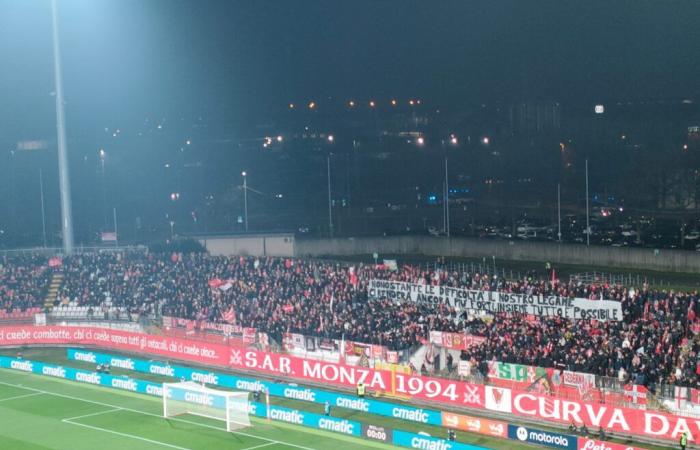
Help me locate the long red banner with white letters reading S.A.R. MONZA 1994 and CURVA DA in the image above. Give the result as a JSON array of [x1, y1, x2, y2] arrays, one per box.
[[0, 325, 700, 442]]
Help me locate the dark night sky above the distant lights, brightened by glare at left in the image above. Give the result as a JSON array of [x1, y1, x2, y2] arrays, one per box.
[[0, 0, 700, 145]]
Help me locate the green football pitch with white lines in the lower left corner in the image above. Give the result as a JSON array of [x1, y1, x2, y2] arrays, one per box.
[[0, 369, 396, 450]]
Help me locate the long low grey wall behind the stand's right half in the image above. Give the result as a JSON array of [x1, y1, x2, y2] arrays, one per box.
[[294, 236, 700, 273]]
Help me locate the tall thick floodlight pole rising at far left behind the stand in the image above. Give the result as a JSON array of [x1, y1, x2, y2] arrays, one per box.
[[51, 0, 73, 255]]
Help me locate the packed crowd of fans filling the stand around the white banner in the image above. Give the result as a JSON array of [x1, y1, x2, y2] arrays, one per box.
[[0, 252, 700, 387]]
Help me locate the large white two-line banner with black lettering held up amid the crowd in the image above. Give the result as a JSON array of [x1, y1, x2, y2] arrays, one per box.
[[367, 280, 622, 321]]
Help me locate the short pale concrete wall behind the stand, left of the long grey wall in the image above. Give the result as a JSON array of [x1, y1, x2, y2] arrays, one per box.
[[196, 234, 294, 258]]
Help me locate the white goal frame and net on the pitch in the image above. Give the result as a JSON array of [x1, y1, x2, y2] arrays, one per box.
[[163, 381, 250, 431]]
